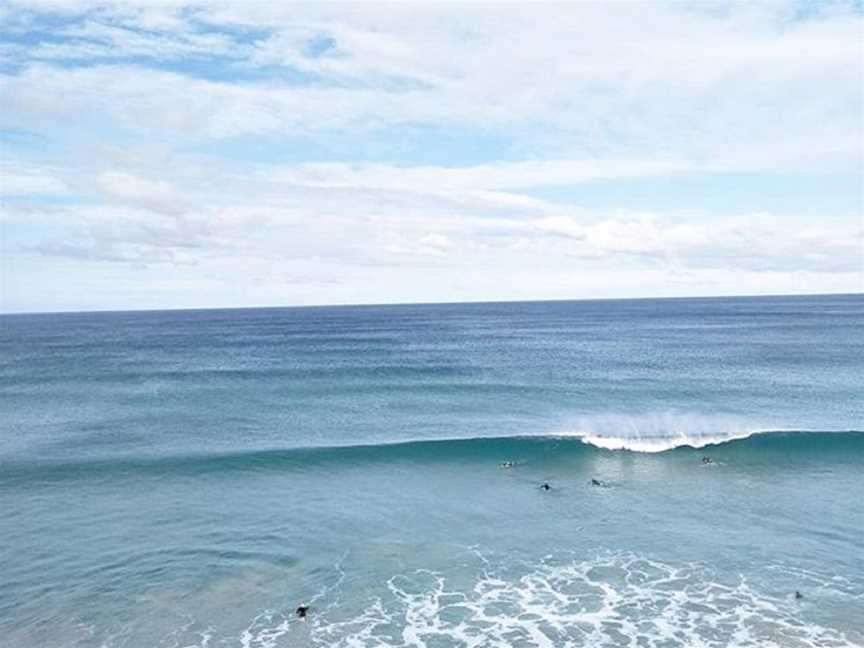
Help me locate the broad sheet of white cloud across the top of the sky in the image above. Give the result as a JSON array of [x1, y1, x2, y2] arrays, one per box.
[[4, 3, 864, 168]]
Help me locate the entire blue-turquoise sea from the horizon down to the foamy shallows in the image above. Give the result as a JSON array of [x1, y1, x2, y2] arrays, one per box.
[[0, 295, 864, 648]]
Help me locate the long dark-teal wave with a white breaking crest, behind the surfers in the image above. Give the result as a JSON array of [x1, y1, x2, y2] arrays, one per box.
[[0, 430, 864, 487]]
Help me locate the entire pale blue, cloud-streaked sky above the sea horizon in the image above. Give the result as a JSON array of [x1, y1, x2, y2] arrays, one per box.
[[0, 0, 864, 313]]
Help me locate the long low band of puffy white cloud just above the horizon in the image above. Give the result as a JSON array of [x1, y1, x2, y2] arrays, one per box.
[[7, 175, 864, 273]]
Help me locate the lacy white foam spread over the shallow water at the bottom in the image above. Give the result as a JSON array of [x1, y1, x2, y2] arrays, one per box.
[[145, 550, 864, 648]]
